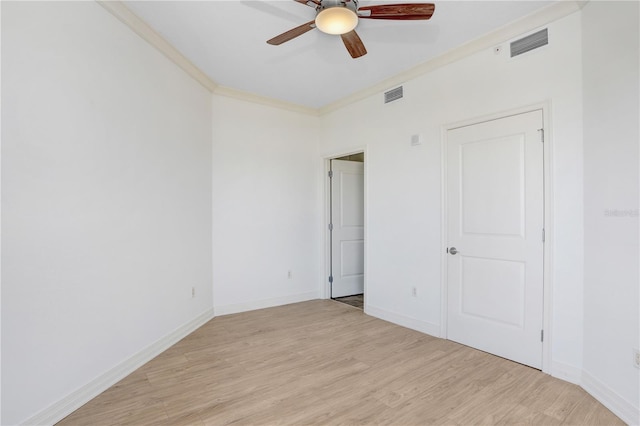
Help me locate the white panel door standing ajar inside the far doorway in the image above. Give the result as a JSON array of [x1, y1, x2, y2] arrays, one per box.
[[331, 160, 364, 297]]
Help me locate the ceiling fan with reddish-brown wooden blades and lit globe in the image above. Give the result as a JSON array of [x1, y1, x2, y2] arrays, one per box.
[[267, 0, 435, 58]]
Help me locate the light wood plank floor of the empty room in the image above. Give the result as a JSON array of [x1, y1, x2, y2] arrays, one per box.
[[59, 300, 623, 425]]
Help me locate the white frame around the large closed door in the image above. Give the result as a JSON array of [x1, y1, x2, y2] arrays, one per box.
[[440, 100, 555, 374]]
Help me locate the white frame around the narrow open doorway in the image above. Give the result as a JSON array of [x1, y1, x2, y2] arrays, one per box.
[[321, 145, 369, 304]]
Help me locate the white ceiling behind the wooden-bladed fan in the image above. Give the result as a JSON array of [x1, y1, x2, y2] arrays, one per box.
[[125, 0, 555, 108]]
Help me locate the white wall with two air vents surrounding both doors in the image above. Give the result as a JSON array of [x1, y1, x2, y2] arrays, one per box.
[[321, 13, 583, 381]]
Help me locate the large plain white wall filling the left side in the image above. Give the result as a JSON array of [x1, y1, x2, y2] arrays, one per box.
[[1, 2, 212, 424]]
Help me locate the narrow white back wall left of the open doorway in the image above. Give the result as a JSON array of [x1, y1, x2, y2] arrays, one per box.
[[213, 95, 322, 315]]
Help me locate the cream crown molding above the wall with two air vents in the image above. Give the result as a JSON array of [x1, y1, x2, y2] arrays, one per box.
[[318, 1, 585, 116]]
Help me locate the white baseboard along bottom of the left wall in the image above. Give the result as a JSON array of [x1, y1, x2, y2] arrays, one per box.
[[22, 309, 213, 425]]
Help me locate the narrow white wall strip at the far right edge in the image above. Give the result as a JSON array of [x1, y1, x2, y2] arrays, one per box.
[[582, 1, 640, 424]]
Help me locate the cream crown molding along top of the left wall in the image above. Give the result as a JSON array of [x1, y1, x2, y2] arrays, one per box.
[[96, 0, 218, 92]]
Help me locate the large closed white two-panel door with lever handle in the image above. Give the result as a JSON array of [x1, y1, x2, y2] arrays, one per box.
[[447, 111, 544, 368]]
